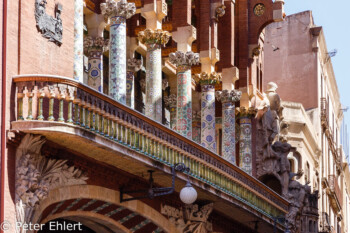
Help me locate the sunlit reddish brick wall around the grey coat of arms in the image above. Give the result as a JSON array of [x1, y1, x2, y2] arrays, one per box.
[[19, 0, 74, 77]]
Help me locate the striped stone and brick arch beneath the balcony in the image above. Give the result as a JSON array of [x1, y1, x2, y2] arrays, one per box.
[[32, 185, 179, 233]]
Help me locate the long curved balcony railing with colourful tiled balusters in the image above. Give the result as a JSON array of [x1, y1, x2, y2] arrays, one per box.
[[13, 75, 288, 218]]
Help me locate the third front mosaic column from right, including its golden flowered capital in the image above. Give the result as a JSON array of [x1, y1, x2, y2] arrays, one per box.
[[199, 72, 221, 153]]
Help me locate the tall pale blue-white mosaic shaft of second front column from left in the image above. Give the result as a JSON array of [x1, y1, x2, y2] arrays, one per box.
[[109, 16, 126, 104]]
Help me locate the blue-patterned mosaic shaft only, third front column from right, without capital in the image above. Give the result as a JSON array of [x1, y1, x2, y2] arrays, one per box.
[[201, 85, 216, 153]]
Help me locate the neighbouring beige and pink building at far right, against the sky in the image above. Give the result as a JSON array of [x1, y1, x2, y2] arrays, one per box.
[[263, 11, 350, 233]]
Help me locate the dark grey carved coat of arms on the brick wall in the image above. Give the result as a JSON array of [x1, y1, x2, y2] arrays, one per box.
[[35, 0, 63, 45]]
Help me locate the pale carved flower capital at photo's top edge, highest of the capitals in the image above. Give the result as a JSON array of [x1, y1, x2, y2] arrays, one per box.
[[101, 0, 136, 20]]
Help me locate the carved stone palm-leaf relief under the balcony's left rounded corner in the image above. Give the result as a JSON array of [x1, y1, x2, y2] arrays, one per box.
[[16, 134, 88, 233]]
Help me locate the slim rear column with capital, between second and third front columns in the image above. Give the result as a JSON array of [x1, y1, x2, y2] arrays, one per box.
[[126, 58, 142, 108]]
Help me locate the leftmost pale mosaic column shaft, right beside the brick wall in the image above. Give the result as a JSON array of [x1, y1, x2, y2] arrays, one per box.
[[73, 0, 84, 82]]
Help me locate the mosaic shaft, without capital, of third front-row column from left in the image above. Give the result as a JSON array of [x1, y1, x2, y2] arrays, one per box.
[[146, 44, 162, 122]]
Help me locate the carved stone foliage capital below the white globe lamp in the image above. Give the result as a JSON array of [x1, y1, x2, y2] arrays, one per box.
[[161, 203, 213, 233]]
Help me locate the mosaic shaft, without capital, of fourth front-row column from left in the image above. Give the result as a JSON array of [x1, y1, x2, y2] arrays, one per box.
[[176, 66, 192, 139]]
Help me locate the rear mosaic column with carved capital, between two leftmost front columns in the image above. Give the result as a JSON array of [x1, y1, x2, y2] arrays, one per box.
[[84, 36, 108, 92]]
